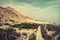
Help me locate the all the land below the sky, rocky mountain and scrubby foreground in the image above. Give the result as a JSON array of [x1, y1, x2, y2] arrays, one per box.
[[0, 7, 60, 40]]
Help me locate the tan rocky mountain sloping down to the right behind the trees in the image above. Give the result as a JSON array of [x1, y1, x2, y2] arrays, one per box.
[[0, 6, 48, 24]]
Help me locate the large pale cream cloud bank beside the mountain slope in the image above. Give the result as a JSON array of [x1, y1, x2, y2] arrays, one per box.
[[17, 4, 60, 23]]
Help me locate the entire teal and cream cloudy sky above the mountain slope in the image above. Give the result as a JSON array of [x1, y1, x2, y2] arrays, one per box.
[[0, 0, 60, 24]]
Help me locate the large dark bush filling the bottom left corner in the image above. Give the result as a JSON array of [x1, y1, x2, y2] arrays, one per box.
[[0, 28, 20, 40]]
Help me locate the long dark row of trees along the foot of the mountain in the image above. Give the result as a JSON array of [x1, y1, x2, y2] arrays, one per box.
[[11, 23, 39, 29]]
